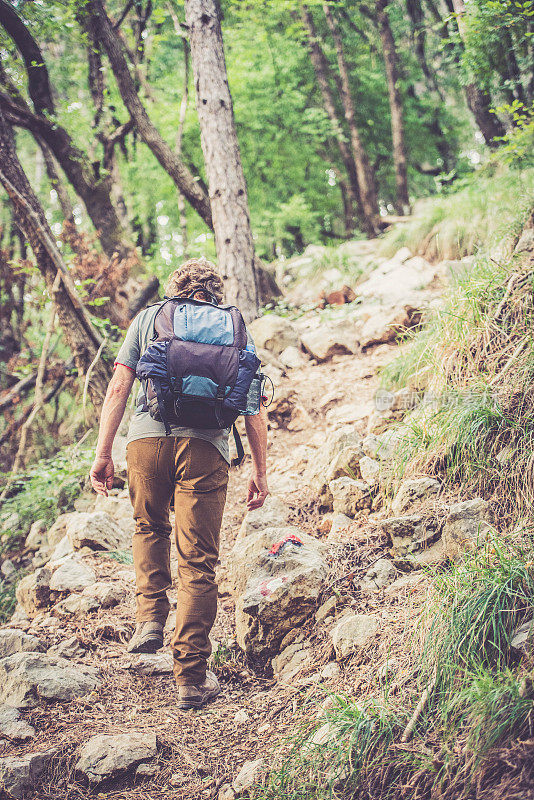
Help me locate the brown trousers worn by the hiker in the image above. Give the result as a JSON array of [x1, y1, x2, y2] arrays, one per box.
[[127, 436, 228, 685]]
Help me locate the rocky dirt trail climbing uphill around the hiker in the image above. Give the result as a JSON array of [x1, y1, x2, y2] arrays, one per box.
[[0, 242, 487, 800]]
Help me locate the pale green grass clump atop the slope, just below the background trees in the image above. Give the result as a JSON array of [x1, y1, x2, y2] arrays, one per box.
[[381, 164, 534, 261]]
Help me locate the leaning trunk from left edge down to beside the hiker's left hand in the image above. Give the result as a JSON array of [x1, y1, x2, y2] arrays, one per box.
[[0, 110, 111, 408]]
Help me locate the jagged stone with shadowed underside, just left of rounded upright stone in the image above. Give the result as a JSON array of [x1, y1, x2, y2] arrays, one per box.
[[380, 514, 442, 569]]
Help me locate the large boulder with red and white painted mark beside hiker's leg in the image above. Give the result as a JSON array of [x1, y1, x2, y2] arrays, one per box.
[[237, 528, 327, 659]]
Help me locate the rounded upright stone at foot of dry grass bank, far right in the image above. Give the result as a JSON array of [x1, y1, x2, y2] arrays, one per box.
[[443, 497, 491, 560]]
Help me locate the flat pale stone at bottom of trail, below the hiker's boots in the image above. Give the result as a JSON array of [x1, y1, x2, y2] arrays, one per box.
[[75, 733, 158, 785]]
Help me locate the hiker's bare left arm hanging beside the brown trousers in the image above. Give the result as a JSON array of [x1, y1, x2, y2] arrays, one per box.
[[89, 364, 135, 497]]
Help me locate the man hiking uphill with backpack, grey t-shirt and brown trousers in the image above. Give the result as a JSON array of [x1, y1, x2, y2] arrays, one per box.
[[90, 259, 269, 709]]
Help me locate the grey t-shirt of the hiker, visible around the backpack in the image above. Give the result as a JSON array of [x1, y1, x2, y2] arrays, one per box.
[[115, 303, 258, 463]]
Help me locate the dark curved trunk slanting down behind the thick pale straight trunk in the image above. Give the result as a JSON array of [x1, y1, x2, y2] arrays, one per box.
[[87, 0, 212, 228]]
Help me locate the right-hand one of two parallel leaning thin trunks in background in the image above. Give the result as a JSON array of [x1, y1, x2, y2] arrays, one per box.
[[323, 3, 379, 235]]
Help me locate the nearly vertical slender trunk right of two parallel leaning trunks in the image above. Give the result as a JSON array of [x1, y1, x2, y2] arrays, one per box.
[[376, 0, 410, 216]]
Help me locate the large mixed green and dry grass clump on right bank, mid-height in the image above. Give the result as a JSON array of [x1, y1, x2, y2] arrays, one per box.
[[382, 203, 534, 518]]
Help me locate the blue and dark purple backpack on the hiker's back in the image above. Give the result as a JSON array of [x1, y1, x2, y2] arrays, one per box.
[[136, 297, 260, 444]]
